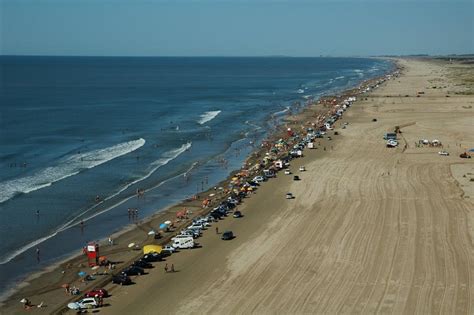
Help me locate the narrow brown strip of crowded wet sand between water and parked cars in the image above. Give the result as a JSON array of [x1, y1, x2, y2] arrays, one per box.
[[0, 60, 398, 311]]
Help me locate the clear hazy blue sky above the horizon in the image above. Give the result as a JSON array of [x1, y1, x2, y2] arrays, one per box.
[[0, 0, 474, 57]]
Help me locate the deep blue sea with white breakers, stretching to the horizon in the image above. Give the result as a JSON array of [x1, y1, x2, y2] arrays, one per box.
[[0, 56, 393, 298]]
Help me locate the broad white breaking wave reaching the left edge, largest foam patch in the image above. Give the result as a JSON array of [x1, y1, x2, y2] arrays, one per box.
[[0, 138, 145, 203]]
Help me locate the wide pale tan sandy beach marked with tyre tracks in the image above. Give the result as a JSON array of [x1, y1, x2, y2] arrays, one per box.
[[0, 59, 474, 314]]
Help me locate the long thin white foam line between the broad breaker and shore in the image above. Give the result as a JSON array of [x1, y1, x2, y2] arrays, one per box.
[[0, 143, 195, 265]]
